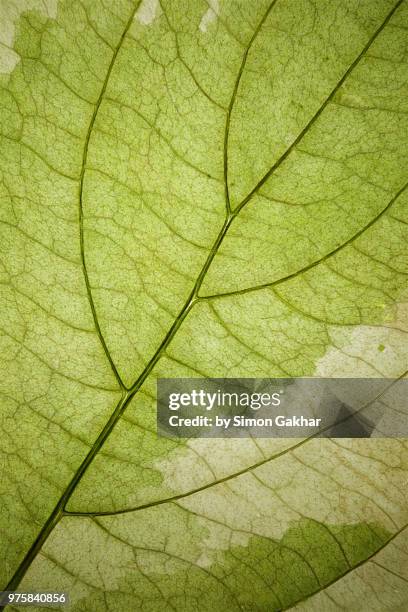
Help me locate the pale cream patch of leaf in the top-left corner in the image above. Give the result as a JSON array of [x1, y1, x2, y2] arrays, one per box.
[[0, 0, 58, 74]]
